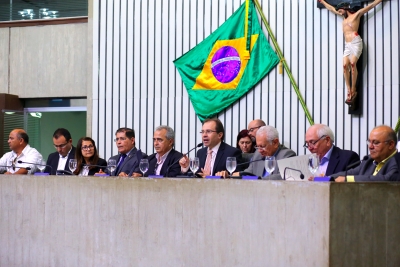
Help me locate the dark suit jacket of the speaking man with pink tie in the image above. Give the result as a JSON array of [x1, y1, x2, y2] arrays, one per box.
[[197, 142, 243, 175]]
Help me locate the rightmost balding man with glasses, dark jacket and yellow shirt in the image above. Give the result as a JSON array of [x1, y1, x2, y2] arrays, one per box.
[[331, 125, 399, 182]]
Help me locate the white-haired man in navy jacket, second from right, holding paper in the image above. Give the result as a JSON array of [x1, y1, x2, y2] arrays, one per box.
[[303, 124, 360, 180]]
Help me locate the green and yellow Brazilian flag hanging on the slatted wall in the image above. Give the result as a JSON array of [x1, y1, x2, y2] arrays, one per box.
[[174, 0, 279, 121]]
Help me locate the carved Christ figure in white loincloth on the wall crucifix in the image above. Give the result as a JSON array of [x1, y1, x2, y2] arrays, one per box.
[[318, 0, 382, 105]]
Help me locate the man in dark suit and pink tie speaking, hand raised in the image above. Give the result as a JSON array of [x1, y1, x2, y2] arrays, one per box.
[[179, 119, 242, 178]]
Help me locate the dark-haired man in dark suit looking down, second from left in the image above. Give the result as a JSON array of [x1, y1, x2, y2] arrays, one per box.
[[44, 128, 75, 175]]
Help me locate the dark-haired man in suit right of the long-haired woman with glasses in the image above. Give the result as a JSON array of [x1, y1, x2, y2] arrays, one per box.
[[108, 128, 147, 177]]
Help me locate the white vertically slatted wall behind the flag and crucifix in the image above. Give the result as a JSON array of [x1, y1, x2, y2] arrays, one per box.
[[92, 0, 400, 158]]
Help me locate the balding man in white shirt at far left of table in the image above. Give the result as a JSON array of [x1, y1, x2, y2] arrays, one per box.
[[0, 129, 42, 174]]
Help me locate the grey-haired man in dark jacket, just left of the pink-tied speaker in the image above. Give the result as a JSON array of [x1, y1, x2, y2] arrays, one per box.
[[145, 125, 183, 177]]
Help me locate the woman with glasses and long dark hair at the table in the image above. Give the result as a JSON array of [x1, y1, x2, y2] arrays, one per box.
[[74, 137, 107, 175]]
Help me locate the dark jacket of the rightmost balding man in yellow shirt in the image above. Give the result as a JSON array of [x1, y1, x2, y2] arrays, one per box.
[[331, 155, 400, 182]]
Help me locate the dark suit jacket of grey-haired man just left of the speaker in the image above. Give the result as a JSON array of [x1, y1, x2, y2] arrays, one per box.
[[145, 149, 183, 177]]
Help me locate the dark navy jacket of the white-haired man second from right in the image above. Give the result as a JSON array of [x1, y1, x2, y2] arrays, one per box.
[[325, 146, 360, 176]]
